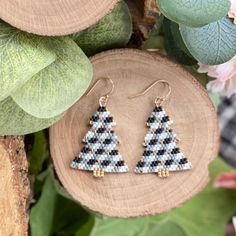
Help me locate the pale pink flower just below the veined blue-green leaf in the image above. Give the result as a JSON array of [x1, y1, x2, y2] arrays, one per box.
[[198, 56, 236, 96]]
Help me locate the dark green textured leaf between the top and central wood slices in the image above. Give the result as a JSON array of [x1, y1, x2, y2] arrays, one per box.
[[72, 1, 132, 56]]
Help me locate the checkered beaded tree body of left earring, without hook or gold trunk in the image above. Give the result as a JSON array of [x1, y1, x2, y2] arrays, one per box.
[[71, 106, 128, 172]]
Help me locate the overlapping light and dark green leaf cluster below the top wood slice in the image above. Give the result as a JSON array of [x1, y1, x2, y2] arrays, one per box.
[[0, 2, 132, 135]]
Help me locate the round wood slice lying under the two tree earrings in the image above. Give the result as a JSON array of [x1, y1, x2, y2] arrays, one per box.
[[50, 49, 219, 217]]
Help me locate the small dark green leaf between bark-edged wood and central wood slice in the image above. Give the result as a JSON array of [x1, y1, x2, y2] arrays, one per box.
[[29, 131, 49, 175]]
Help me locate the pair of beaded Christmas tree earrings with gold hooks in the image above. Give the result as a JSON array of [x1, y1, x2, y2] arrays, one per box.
[[70, 78, 192, 178]]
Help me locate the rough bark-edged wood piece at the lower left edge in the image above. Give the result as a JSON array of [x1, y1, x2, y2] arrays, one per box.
[[0, 137, 29, 236]]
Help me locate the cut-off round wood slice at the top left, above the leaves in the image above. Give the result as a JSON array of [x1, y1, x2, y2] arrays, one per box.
[[0, 0, 118, 35]]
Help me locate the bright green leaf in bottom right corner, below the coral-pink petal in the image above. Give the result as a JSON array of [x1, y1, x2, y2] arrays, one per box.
[[153, 159, 236, 236]]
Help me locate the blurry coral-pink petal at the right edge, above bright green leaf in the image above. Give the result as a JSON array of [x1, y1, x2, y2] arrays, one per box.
[[214, 172, 236, 189]]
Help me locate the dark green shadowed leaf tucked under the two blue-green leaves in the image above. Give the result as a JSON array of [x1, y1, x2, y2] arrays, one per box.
[[163, 18, 197, 65]]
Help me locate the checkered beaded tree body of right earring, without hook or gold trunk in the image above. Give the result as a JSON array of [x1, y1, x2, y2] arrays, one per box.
[[135, 106, 192, 173]]
